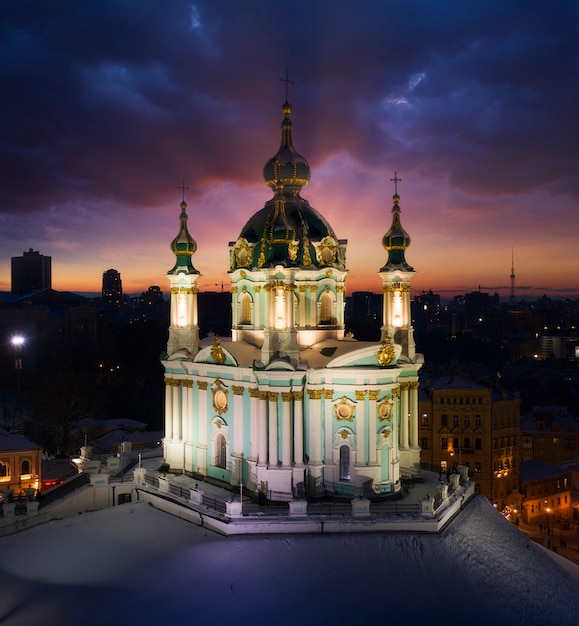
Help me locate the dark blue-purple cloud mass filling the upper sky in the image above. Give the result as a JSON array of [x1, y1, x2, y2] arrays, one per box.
[[0, 0, 579, 292]]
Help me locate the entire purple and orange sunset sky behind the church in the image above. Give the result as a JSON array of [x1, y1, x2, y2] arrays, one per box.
[[0, 0, 579, 298]]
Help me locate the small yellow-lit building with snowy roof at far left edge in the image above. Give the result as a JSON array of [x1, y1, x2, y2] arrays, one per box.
[[0, 429, 42, 497]]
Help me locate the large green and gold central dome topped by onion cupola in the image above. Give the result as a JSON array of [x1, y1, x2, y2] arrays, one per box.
[[230, 102, 346, 271]]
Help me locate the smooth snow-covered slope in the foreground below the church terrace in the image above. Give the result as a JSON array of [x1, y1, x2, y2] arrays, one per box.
[[0, 497, 579, 626]]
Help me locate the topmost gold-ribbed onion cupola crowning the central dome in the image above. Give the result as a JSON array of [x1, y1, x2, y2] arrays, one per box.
[[263, 102, 311, 194]]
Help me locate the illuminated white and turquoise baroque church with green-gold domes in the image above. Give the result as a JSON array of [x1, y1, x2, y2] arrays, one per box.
[[162, 95, 423, 500]]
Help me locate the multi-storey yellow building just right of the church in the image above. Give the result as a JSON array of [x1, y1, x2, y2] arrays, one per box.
[[419, 376, 520, 510]]
